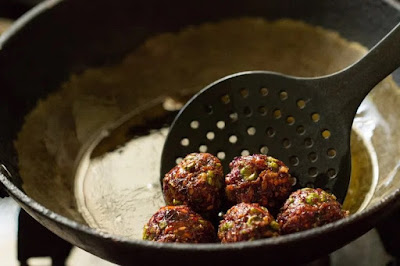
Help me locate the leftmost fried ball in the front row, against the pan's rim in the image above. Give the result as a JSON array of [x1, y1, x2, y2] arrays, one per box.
[[143, 206, 216, 243]]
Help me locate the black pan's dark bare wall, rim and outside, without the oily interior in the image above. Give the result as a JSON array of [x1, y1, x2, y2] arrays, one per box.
[[0, 0, 400, 265]]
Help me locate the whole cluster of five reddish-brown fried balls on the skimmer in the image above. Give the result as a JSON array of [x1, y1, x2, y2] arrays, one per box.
[[143, 153, 348, 243]]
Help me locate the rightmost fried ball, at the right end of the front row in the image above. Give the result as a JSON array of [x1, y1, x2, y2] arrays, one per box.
[[277, 188, 349, 234]]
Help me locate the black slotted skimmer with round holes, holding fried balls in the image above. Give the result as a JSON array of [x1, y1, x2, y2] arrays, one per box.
[[161, 24, 400, 201]]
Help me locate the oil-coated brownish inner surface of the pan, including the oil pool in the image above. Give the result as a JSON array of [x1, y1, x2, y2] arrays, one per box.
[[15, 18, 400, 243]]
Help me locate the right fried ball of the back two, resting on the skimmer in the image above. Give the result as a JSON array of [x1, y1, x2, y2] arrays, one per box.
[[225, 154, 294, 208]]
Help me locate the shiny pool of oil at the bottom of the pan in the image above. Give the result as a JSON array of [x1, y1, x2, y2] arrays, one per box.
[[75, 95, 376, 239]]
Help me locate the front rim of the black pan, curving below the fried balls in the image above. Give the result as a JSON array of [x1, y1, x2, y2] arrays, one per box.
[[0, 168, 400, 252]]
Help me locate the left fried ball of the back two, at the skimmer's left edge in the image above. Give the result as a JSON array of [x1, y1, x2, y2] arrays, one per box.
[[163, 153, 224, 213]]
